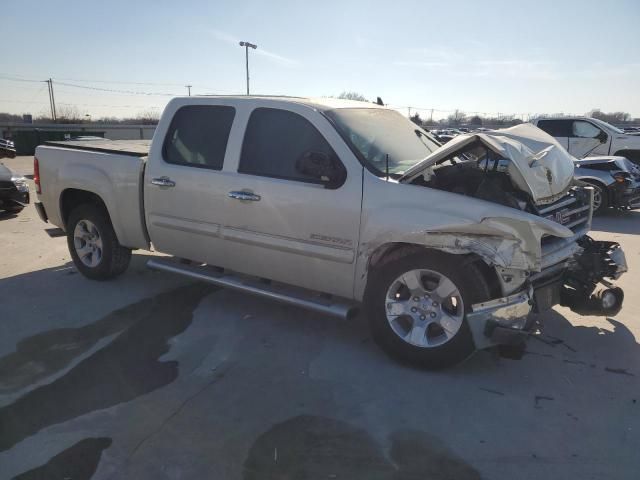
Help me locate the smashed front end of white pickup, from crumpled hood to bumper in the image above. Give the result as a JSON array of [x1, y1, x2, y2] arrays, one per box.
[[400, 125, 627, 349]]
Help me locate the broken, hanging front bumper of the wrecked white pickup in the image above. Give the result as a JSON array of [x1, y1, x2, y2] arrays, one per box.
[[467, 235, 627, 349]]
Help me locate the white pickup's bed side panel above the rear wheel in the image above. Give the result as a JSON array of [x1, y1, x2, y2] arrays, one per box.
[[36, 146, 149, 248]]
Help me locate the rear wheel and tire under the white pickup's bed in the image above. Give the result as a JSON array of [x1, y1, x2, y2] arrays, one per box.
[[67, 204, 131, 280]]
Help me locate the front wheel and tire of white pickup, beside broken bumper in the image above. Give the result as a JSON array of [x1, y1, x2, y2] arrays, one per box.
[[365, 250, 491, 369]]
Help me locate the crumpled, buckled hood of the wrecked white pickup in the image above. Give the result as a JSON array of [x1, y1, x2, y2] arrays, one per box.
[[399, 123, 575, 204]]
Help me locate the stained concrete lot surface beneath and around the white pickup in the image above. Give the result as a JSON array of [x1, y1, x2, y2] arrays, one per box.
[[0, 158, 640, 480]]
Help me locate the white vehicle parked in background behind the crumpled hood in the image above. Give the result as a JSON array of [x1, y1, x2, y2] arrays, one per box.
[[533, 117, 640, 165]]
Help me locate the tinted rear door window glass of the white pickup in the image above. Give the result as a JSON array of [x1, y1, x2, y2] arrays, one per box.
[[163, 105, 235, 170]]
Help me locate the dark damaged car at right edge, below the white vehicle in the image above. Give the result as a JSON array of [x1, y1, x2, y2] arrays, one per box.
[[575, 157, 640, 214]]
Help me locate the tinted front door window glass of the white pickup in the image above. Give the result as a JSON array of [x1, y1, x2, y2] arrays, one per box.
[[238, 108, 345, 188]]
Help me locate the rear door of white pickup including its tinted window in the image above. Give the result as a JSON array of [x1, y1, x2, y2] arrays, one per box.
[[144, 105, 236, 265]]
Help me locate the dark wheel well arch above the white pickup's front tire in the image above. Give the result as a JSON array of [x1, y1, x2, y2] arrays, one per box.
[[368, 242, 502, 298]]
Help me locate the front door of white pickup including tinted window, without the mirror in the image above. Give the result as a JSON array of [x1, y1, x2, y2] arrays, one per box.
[[224, 105, 362, 297]]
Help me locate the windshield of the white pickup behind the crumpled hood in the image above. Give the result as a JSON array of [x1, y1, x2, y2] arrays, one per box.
[[326, 108, 440, 176]]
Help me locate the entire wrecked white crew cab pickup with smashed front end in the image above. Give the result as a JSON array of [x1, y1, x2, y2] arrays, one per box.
[[34, 96, 626, 368]]
